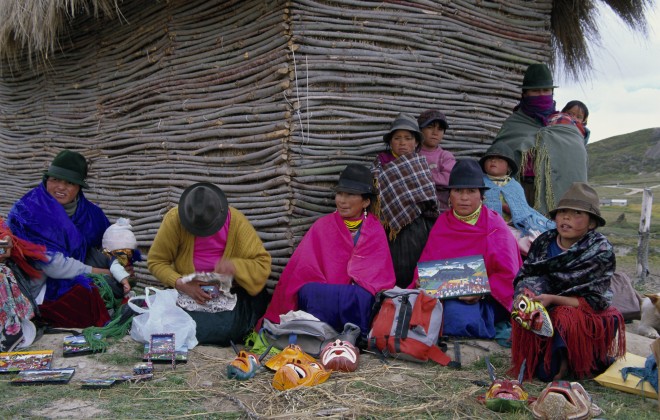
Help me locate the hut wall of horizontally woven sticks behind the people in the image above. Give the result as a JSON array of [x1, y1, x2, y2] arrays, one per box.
[[0, 0, 551, 287]]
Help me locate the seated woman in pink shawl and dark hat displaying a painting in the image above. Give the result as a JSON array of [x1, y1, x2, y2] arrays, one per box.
[[420, 159, 522, 338]]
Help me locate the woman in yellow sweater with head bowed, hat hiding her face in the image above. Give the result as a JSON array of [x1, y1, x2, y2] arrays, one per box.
[[147, 182, 271, 346]]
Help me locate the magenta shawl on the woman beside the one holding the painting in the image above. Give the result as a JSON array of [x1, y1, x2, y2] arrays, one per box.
[[265, 212, 398, 323]]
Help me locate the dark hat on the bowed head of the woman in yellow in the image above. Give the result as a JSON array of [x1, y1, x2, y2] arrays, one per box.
[[179, 182, 229, 237]]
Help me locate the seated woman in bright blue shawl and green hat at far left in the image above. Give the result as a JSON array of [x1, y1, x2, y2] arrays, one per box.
[[7, 150, 110, 328]]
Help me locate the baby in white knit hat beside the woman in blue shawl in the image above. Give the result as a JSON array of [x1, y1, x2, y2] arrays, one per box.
[[102, 217, 141, 295]]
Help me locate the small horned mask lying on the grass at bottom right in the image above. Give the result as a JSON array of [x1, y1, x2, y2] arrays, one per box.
[[480, 356, 529, 412]]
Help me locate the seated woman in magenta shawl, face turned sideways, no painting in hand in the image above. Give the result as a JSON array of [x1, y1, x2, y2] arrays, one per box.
[[258, 164, 395, 337]]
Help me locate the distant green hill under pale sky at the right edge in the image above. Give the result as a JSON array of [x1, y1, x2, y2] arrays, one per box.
[[587, 128, 660, 180]]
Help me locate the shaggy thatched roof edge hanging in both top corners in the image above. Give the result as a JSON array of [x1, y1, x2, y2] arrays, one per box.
[[0, 0, 655, 79]]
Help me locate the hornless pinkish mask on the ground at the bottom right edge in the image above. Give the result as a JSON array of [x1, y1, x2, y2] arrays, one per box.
[[530, 381, 603, 420]]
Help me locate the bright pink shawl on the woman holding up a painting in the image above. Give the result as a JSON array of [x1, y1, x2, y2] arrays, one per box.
[[415, 206, 522, 311]]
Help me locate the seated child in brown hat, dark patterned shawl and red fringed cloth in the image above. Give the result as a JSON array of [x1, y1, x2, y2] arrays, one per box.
[[511, 182, 626, 381]]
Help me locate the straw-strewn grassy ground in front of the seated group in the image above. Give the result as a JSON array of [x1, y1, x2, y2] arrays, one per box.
[[0, 339, 658, 420]]
